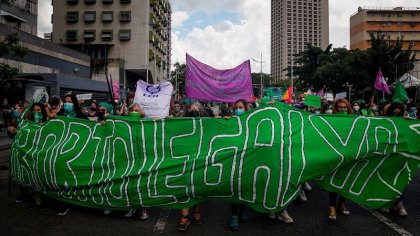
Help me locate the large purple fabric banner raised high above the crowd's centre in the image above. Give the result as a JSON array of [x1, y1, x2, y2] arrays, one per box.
[[185, 54, 254, 102]]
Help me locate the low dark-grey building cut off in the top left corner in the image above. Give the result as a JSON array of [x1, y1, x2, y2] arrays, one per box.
[[0, 0, 38, 35]]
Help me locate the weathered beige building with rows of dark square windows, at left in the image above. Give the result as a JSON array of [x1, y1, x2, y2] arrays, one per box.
[[52, 0, 171, 92]]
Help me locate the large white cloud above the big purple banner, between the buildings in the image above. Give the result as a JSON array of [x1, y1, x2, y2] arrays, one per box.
[[172, 0, 271, 72]]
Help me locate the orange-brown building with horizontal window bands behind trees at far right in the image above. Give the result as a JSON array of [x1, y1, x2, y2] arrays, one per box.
[[350, 7, 420, 53]]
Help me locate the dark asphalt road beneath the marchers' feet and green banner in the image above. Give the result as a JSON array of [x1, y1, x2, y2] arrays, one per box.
[[0, 151, 420, 236]]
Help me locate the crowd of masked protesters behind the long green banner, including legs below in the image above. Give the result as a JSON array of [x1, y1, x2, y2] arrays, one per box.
[[0, 89, 419, 231]]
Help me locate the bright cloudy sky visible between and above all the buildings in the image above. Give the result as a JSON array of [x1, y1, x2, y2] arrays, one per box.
[[38, 0, 420, 73]]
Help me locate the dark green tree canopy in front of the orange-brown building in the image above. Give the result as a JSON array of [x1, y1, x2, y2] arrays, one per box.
[[288, 32, 415, 93]]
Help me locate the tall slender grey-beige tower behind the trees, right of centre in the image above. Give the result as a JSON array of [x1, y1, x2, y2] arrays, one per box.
[[271, 0, 329, 81]]
